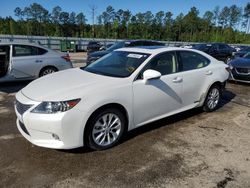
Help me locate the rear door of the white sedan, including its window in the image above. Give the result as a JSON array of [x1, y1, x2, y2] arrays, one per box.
[[177, 51, 213, 108]]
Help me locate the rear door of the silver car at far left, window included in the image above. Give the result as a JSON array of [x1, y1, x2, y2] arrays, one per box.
[[11, 45, 46, 78]]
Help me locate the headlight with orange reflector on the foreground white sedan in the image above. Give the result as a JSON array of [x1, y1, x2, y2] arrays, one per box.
[[31, 99, 81, 114]]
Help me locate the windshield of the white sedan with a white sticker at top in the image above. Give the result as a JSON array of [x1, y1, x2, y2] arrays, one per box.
[[84, 51, 150, 78]]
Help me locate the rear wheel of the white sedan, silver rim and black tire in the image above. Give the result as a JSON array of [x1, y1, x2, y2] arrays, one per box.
[[203, 85, 222, 112]]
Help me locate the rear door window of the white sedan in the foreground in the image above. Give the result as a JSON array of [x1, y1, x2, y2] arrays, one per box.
[[179, 51, 210, 71]]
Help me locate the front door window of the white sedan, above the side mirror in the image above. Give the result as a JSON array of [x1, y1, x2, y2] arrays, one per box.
[[143, 52, 177, 75]]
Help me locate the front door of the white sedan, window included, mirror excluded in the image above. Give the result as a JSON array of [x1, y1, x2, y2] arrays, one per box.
[[133, 52, 182, 126]]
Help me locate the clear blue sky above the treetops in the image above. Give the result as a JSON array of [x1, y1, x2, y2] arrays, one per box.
[[0, 0, 249, 22]]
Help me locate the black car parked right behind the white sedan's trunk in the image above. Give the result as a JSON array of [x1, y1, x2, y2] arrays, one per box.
[[193, 43, 236, 63]]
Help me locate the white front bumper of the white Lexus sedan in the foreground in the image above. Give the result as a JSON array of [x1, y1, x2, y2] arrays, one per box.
[[15, 92, 88, 149]]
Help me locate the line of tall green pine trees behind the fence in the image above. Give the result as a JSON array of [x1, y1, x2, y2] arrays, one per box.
[[0, 3, 250, 44]]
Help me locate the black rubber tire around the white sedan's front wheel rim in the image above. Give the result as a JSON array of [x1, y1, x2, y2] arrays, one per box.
[[84, 108, 126, 150]]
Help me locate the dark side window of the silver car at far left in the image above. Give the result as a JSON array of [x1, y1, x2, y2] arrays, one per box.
[[13, 45, 47, 57]]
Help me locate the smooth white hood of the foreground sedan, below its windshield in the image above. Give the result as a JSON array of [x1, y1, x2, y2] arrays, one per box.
[[21, 68, 121, 101]]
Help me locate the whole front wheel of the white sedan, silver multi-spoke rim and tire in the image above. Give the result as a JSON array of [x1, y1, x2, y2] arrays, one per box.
[[85, 108, 126, 150]]
